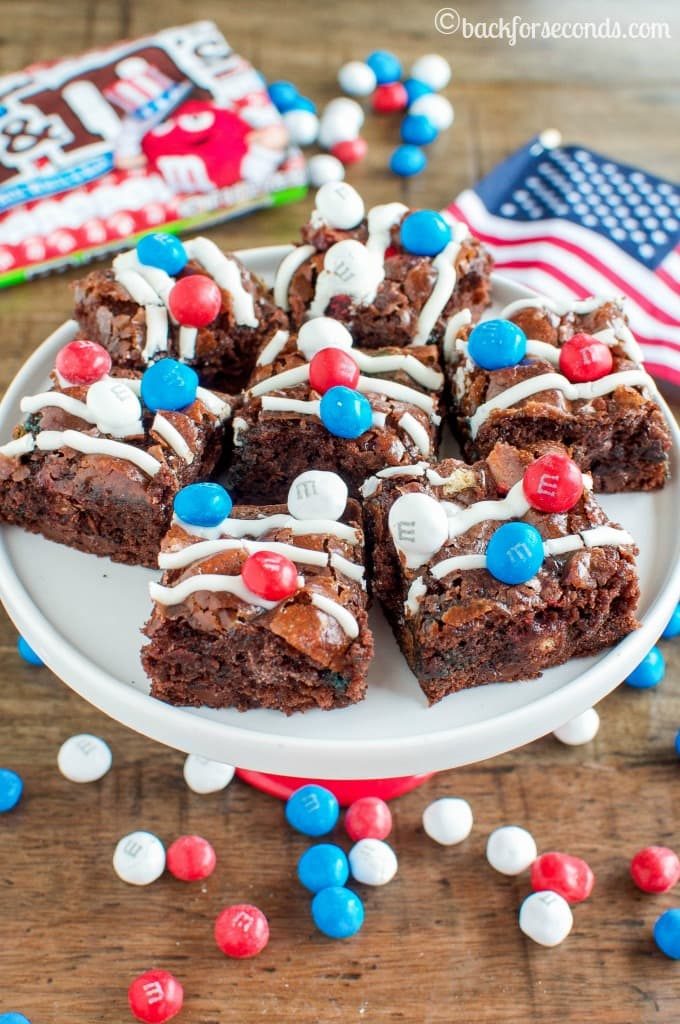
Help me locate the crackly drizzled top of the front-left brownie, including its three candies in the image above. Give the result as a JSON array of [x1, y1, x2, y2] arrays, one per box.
[[146, 470, 366, 670]]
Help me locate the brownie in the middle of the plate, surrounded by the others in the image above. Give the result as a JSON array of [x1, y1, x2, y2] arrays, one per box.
[[228, 316, 443, 502]]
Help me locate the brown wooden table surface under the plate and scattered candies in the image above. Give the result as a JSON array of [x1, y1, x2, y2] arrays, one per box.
[[0, 0, 680, 1024]]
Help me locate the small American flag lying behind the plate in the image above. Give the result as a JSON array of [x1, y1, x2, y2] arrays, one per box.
[[449, 131, 680, 385]]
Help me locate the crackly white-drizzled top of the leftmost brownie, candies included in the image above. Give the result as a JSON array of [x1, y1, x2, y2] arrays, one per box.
[[0, 340, 230, 499]]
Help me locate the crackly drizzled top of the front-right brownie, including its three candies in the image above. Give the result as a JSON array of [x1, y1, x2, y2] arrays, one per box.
[[363, 443, 636, 625]]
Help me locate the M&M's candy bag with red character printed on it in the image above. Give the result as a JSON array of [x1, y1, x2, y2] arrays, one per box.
[[0, 22, 306, 286]]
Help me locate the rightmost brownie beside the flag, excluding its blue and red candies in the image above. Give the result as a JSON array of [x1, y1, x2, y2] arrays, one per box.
[[444, 297, 671, 492]]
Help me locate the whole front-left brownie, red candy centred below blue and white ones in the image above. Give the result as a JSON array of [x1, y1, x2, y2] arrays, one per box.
[[141, 471, 373, 715]]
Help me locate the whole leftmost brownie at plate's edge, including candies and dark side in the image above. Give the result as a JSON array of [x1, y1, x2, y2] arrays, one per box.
[[0, 333, 230, 566]]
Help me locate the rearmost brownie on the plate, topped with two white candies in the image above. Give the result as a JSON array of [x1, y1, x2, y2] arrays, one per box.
[[274, 182, 492, 348]]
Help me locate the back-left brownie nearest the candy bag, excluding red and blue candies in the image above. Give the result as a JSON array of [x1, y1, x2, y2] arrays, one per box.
[[74, 238, 288, 393]]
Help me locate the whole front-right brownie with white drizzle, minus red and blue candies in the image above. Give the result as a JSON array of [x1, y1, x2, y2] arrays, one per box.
[[363, 443, 639, 703]]
